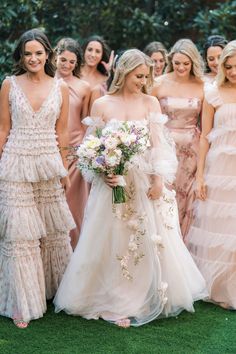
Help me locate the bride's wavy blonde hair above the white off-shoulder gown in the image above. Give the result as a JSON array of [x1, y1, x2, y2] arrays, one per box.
[[109, 49, 154, 95]]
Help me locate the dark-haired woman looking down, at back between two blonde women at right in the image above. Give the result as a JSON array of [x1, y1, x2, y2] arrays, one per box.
[[203, 35, 228, 83]]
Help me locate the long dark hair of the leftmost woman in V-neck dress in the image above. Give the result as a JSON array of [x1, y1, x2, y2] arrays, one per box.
[[12, 28, 56, 77]]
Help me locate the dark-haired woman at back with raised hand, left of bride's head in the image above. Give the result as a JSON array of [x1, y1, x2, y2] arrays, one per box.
[[81, 36, 110, 89]]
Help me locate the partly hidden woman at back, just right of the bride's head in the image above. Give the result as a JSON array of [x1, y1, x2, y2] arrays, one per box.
[[143, 42, 167, 78]]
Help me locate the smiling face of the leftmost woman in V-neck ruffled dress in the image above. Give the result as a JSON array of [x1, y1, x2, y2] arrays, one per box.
[[23, 40, 48, 73]]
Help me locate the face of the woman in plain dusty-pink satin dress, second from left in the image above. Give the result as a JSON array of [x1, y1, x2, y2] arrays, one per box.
[[56, 50, 77, 77]]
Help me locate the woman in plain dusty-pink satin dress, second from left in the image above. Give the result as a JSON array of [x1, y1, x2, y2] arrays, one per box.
[[55, 38, 90, 249]]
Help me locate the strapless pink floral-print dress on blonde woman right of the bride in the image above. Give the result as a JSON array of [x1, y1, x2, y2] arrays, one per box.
[[159, 97, 201, 240]]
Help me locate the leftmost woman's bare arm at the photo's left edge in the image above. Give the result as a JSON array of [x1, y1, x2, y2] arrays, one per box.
[[0, 80, 11, 157]]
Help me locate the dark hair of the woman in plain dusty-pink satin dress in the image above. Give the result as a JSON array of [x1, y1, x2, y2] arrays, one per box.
[[55, 38, 83, 78]]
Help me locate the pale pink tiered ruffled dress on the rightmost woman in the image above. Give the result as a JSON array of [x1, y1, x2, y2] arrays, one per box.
[[187, 85, 236, 309]]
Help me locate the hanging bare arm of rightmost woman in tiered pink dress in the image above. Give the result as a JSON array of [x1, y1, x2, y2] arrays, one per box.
[[196, 100, 215, 200]]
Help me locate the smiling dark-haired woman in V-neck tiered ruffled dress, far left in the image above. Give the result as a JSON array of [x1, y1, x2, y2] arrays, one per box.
[[0, 29, 74, 328]]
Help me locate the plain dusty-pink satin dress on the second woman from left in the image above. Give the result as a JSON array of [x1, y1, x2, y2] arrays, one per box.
[[65, 80, 89, 248]]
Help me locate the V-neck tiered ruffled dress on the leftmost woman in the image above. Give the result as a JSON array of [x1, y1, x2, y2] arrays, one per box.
[[0, 76, 74, 321]]
